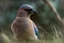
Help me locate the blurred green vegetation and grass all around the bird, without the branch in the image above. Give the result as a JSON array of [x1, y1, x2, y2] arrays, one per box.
[[0, 0, 64, 43]]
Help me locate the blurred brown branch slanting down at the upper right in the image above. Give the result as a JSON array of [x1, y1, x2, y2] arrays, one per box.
[[42, 0, 64, 27]]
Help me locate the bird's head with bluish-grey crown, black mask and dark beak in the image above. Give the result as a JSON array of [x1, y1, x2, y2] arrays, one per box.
[[16, 4, 37, 15]]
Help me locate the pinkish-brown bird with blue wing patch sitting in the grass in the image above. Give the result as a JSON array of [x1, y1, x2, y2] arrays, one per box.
[[11, 4, 38, 40]]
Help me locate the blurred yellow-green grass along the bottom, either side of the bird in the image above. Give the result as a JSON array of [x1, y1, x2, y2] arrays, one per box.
[[0, 27, 64, 43]]
